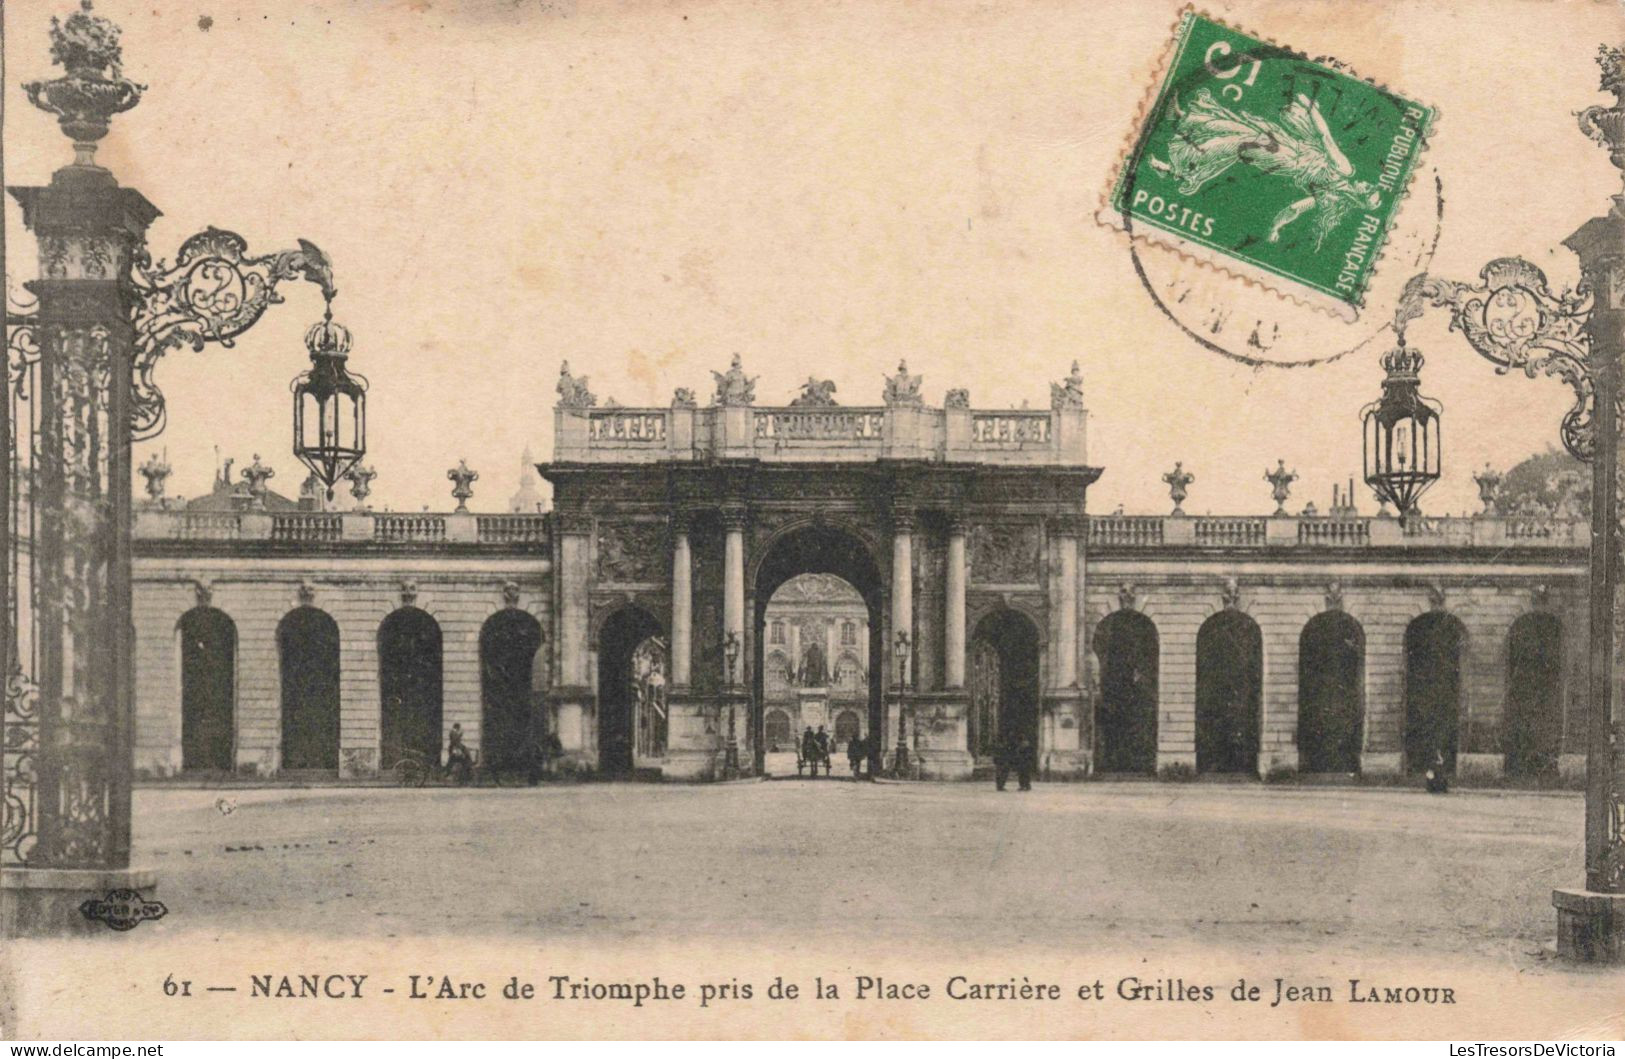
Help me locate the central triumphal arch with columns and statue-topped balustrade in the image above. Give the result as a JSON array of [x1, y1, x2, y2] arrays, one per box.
[[538, 356, 1100, 778]]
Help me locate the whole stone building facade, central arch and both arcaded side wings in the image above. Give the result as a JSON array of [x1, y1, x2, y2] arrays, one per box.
[[123, 357, 1588, 780]]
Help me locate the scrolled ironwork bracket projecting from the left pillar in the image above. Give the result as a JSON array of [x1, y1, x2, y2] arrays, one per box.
[[128, 227, 336, 442]]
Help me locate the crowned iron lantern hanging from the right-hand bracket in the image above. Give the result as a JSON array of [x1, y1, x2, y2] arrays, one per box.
[[1360, 346, 1443, 518]]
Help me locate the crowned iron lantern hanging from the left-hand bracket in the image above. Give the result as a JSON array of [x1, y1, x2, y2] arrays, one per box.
[[293, 304, 367, 500]]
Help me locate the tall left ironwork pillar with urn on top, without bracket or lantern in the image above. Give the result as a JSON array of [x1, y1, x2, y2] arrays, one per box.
[[0, 11, 158, 936]]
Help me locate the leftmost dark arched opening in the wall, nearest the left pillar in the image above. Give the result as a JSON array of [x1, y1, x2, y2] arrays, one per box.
[[179, 607, 237, 772]]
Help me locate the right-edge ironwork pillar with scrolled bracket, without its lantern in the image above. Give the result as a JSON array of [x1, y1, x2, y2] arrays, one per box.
[[1394, 45, 1625, 962]]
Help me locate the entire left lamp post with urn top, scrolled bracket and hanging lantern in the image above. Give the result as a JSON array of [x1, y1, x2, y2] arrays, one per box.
[[0, 0, 364, 934]]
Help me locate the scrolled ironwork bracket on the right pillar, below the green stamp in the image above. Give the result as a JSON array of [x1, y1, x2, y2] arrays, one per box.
[[1394, 257, 1596, 463]]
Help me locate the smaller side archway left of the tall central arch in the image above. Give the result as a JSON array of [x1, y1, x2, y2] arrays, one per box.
[[598, 607, 666, 775]]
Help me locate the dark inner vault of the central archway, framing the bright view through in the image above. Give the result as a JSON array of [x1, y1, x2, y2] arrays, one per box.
[[751, 521, 891, 773]]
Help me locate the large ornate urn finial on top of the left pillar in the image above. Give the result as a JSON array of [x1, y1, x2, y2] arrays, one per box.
[[23, 0, 146, 166]]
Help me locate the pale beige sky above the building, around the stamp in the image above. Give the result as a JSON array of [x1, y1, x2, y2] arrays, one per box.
[[3, 0, 1625, 513]]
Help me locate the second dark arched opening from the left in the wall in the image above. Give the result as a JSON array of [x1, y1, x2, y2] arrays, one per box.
[[276, 606, 338, 772]]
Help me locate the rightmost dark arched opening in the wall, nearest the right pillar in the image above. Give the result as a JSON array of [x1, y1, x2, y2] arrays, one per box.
[[1502, 612, 1563, 776]]
